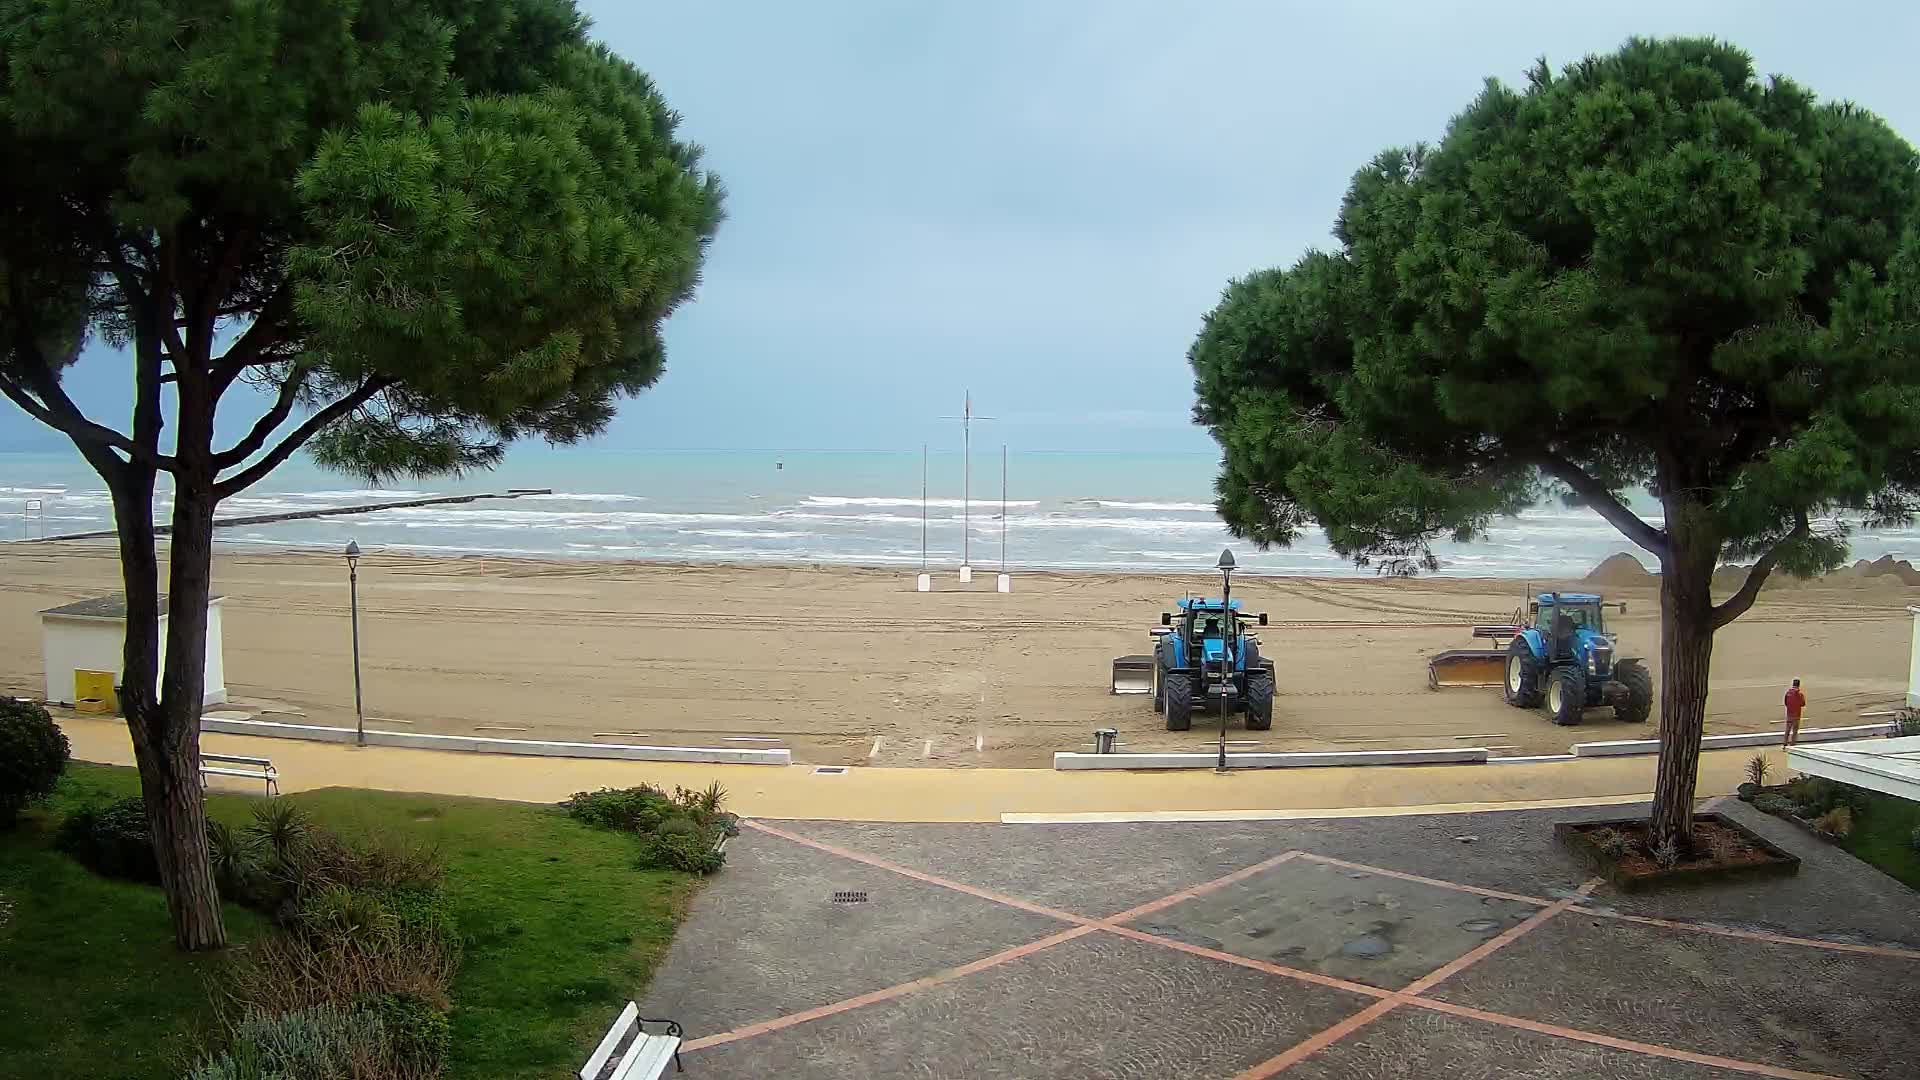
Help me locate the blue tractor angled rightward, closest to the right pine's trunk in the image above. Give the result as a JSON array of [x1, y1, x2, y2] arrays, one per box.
[[1503, 592, 1653, 724]]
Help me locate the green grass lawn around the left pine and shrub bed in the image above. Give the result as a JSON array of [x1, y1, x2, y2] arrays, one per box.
[[0, 765, 695, 1080]]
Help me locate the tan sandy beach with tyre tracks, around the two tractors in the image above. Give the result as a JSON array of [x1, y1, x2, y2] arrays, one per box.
[[0, 544, 1920, 767]]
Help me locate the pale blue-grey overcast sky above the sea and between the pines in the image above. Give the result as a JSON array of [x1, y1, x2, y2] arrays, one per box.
[[0, 0, 1920, 450]]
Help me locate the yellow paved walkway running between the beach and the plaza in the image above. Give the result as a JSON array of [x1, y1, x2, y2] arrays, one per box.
[[61, 719, 1786, 821]]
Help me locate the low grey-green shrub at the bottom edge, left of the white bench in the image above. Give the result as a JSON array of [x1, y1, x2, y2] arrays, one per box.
[[186, 1005, 392, 1080]]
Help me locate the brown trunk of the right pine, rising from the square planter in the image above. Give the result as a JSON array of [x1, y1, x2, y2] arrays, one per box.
[[1651, 500, 1720, 851]]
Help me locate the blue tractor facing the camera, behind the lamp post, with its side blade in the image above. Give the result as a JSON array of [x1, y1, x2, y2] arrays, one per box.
[[1112, 596, 1273, 732]]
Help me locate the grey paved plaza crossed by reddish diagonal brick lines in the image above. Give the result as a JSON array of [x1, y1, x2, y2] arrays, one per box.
[[641, 799, 1920, 1080]]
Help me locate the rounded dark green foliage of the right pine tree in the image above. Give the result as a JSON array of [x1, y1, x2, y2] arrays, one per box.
[[1190, 38, 1920, 577]]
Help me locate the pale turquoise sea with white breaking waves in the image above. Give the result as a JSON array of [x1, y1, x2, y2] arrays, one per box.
[[0, 446, 1920, 578]]
